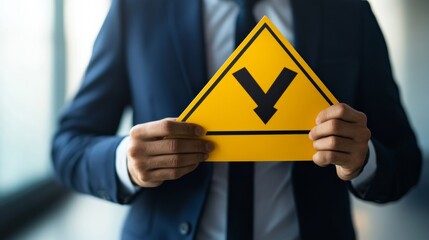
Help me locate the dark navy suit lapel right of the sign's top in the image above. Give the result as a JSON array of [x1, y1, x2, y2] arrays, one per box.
[[292, 0, 322, 70]]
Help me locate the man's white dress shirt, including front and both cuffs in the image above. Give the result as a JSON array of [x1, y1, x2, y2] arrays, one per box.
[[116, 0, 376, 240]]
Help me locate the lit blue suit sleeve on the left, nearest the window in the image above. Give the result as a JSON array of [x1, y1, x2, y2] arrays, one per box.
[[52, 0, 130, 202]]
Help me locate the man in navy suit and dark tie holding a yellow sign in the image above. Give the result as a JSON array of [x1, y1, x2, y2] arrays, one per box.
[[52, 0, 421, 240]]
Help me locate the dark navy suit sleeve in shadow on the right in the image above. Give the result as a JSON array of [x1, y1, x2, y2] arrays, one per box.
[[352, 1, 421, 203]]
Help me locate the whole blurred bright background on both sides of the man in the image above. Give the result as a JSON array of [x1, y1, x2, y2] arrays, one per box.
[[0, 0, 429, 240]]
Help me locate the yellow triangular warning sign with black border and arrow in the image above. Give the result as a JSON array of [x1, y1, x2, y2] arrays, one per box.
[[178, 17, 338, 161]]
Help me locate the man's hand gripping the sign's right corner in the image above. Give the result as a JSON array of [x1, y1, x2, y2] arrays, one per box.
[[309, 103, 371, 181]]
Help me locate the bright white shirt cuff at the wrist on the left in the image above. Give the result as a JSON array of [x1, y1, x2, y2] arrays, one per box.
[[116, 137, 139, 196]]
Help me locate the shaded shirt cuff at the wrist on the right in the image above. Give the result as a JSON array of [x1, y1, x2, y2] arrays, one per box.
[[351, 140, 377, 193]]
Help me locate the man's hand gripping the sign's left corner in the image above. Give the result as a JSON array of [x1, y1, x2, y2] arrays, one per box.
[[127, 118, 214, 187]]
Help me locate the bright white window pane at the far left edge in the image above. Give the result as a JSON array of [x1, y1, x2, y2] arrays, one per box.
[[0, 0, 54, 200]]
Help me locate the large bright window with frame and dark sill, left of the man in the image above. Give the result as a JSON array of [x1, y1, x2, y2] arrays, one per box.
[[0, 0, 110, 236]]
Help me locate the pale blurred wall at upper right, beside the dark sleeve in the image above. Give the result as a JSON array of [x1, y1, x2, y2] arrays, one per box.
[[370, 0, 429, 159]]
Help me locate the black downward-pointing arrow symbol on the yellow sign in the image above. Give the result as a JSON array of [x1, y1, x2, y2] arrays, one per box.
[[233, 68, 297, 124]]
